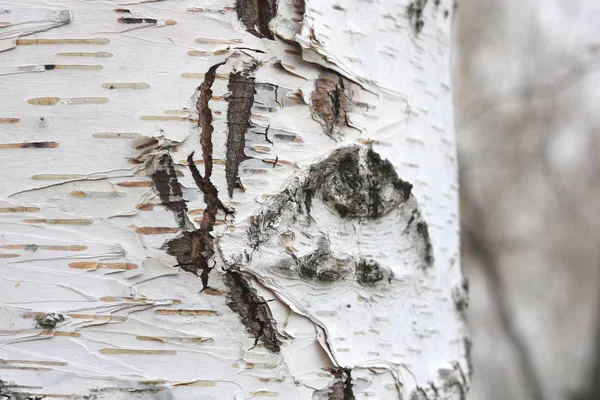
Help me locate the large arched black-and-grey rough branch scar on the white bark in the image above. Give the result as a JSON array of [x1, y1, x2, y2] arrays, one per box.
[[248, 146, 433, 289]]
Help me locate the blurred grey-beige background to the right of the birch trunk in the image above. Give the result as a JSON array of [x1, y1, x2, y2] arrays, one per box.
[[453, 0, 600, 400]]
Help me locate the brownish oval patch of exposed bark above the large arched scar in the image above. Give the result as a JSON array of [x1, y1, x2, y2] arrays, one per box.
[[311, 71, 352, 138]]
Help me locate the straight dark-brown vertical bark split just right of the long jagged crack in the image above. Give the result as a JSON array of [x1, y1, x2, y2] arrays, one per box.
[[225, 71, 256, 197]]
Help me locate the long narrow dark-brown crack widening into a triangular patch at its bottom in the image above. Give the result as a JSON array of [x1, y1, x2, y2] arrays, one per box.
[[163, 63, 232, 290]]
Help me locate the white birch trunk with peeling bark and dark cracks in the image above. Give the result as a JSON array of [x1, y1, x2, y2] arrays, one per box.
[[0, 0, 471, 400]]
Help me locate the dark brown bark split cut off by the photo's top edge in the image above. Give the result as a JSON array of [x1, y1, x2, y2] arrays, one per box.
[[235, 0, 277, 40]]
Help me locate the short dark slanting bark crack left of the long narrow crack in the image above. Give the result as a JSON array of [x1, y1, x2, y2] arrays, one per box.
[[152, 153, 188, 231]]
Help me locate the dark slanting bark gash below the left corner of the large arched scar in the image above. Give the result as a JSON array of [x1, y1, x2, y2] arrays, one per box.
[[225, 268, 281, 353]]
